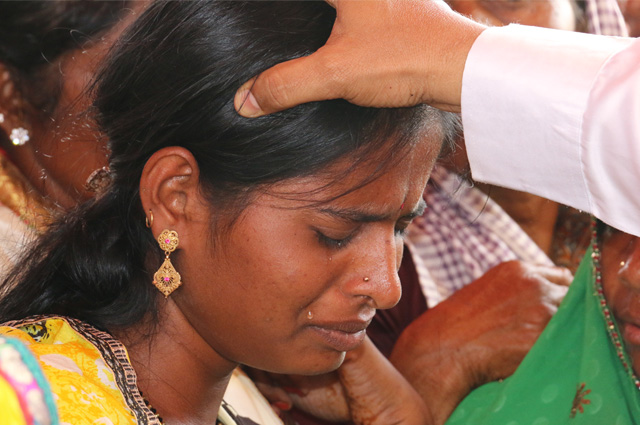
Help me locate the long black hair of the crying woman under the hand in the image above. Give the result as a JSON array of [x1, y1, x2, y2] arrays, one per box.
[[0, 1, 456, 328]]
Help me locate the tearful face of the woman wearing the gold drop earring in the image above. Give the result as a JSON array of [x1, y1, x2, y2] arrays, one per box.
[[171, 136, 440, 374]]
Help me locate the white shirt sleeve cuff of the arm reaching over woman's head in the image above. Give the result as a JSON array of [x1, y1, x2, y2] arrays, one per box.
[[462, 25, 640, 236]]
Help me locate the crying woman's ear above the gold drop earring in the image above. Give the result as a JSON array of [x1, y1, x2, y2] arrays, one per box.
[[140, 146, 206, 236]]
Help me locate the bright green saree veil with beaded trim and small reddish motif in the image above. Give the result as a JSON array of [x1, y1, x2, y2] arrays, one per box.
[[447, 245, 640, 425]]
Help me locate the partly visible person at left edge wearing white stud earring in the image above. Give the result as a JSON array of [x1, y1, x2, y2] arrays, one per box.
[[0, 1, 144, 268]]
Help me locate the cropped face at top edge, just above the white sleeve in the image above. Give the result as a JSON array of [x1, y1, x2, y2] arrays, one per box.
[[448, 0, 576, 31]]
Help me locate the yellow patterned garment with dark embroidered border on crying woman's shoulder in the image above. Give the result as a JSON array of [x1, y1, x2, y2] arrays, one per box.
[[0, 317, 160, 425]]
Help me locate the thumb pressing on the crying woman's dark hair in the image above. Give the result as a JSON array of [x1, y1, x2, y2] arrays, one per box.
[[233, 49, 339, 118]]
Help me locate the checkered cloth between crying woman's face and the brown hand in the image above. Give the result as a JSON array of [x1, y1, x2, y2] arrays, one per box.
[[406, 166, 553, 308]]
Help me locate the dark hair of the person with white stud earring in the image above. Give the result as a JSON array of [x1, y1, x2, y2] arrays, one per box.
[[0, 0, 128, 110]]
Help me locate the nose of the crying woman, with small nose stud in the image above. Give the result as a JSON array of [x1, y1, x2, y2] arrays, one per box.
[[350, 237, 403, 310]]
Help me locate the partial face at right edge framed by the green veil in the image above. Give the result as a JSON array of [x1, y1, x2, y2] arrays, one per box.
[[602, 229, 640, 374]]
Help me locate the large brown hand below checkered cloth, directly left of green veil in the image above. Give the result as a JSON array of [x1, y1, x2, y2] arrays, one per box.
[[390, 261, 572, 424]]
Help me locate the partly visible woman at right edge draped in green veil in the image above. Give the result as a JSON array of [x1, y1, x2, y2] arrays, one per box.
[[447, 217, 640, 425]]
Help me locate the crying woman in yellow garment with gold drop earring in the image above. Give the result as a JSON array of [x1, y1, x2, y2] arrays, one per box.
[[0, 2, 456, 423]]
